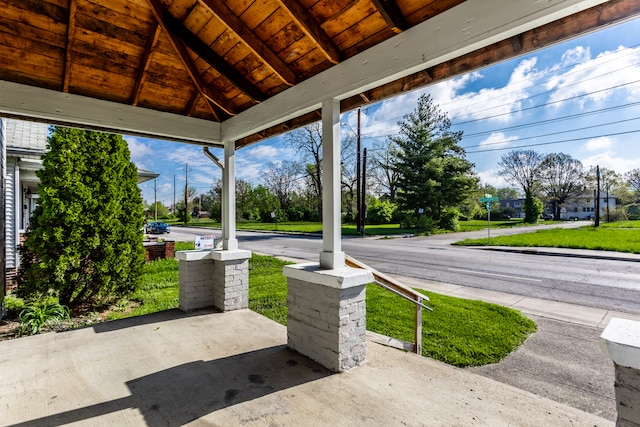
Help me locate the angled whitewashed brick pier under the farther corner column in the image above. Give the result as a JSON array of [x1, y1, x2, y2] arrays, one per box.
[[176, 250, 251, 311]]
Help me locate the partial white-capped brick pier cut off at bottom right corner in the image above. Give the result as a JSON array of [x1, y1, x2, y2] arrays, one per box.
[[600, 317, 640, 427]]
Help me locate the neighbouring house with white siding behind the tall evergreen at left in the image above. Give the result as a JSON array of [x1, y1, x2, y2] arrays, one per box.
[[0, 118, 158, 288]]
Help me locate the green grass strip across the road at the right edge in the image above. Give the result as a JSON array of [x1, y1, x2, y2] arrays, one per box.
[[456, 221, 640, 253]]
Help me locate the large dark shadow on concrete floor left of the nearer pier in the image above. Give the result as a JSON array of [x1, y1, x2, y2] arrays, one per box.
[[8, 345, 332, 427]]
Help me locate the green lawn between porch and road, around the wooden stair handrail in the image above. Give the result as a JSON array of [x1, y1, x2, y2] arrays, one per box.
[[249, 254, 536, 367]]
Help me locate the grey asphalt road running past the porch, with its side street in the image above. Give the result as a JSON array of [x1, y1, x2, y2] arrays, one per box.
[[171, 222, 640, 314]]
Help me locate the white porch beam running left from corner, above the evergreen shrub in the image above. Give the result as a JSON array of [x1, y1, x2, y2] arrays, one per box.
[[0, 80, 221, 146]]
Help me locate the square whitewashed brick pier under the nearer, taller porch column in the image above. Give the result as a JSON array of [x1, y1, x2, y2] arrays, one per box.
[[284, 263, 373, 372]]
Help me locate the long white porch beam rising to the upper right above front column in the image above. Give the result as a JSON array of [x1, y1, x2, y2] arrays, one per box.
[[222, 0, 605, 141]]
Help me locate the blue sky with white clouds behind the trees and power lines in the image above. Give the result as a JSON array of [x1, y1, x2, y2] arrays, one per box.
[[125, 19, 640, 205]]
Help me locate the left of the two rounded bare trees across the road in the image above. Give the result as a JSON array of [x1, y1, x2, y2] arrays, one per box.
[[498, 150, 544, 223]]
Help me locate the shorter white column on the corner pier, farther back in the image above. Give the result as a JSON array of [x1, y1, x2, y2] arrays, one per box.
[[222, 141, 238, 251]]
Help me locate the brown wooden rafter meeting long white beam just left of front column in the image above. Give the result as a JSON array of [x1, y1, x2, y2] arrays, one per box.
[[200, 0, 298, 86]]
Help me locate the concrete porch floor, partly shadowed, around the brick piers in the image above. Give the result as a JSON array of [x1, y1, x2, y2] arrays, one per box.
[[0, 310, 613, 426]]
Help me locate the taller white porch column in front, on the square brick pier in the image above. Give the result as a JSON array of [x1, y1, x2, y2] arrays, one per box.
[[320, 99, 344, 270]]
